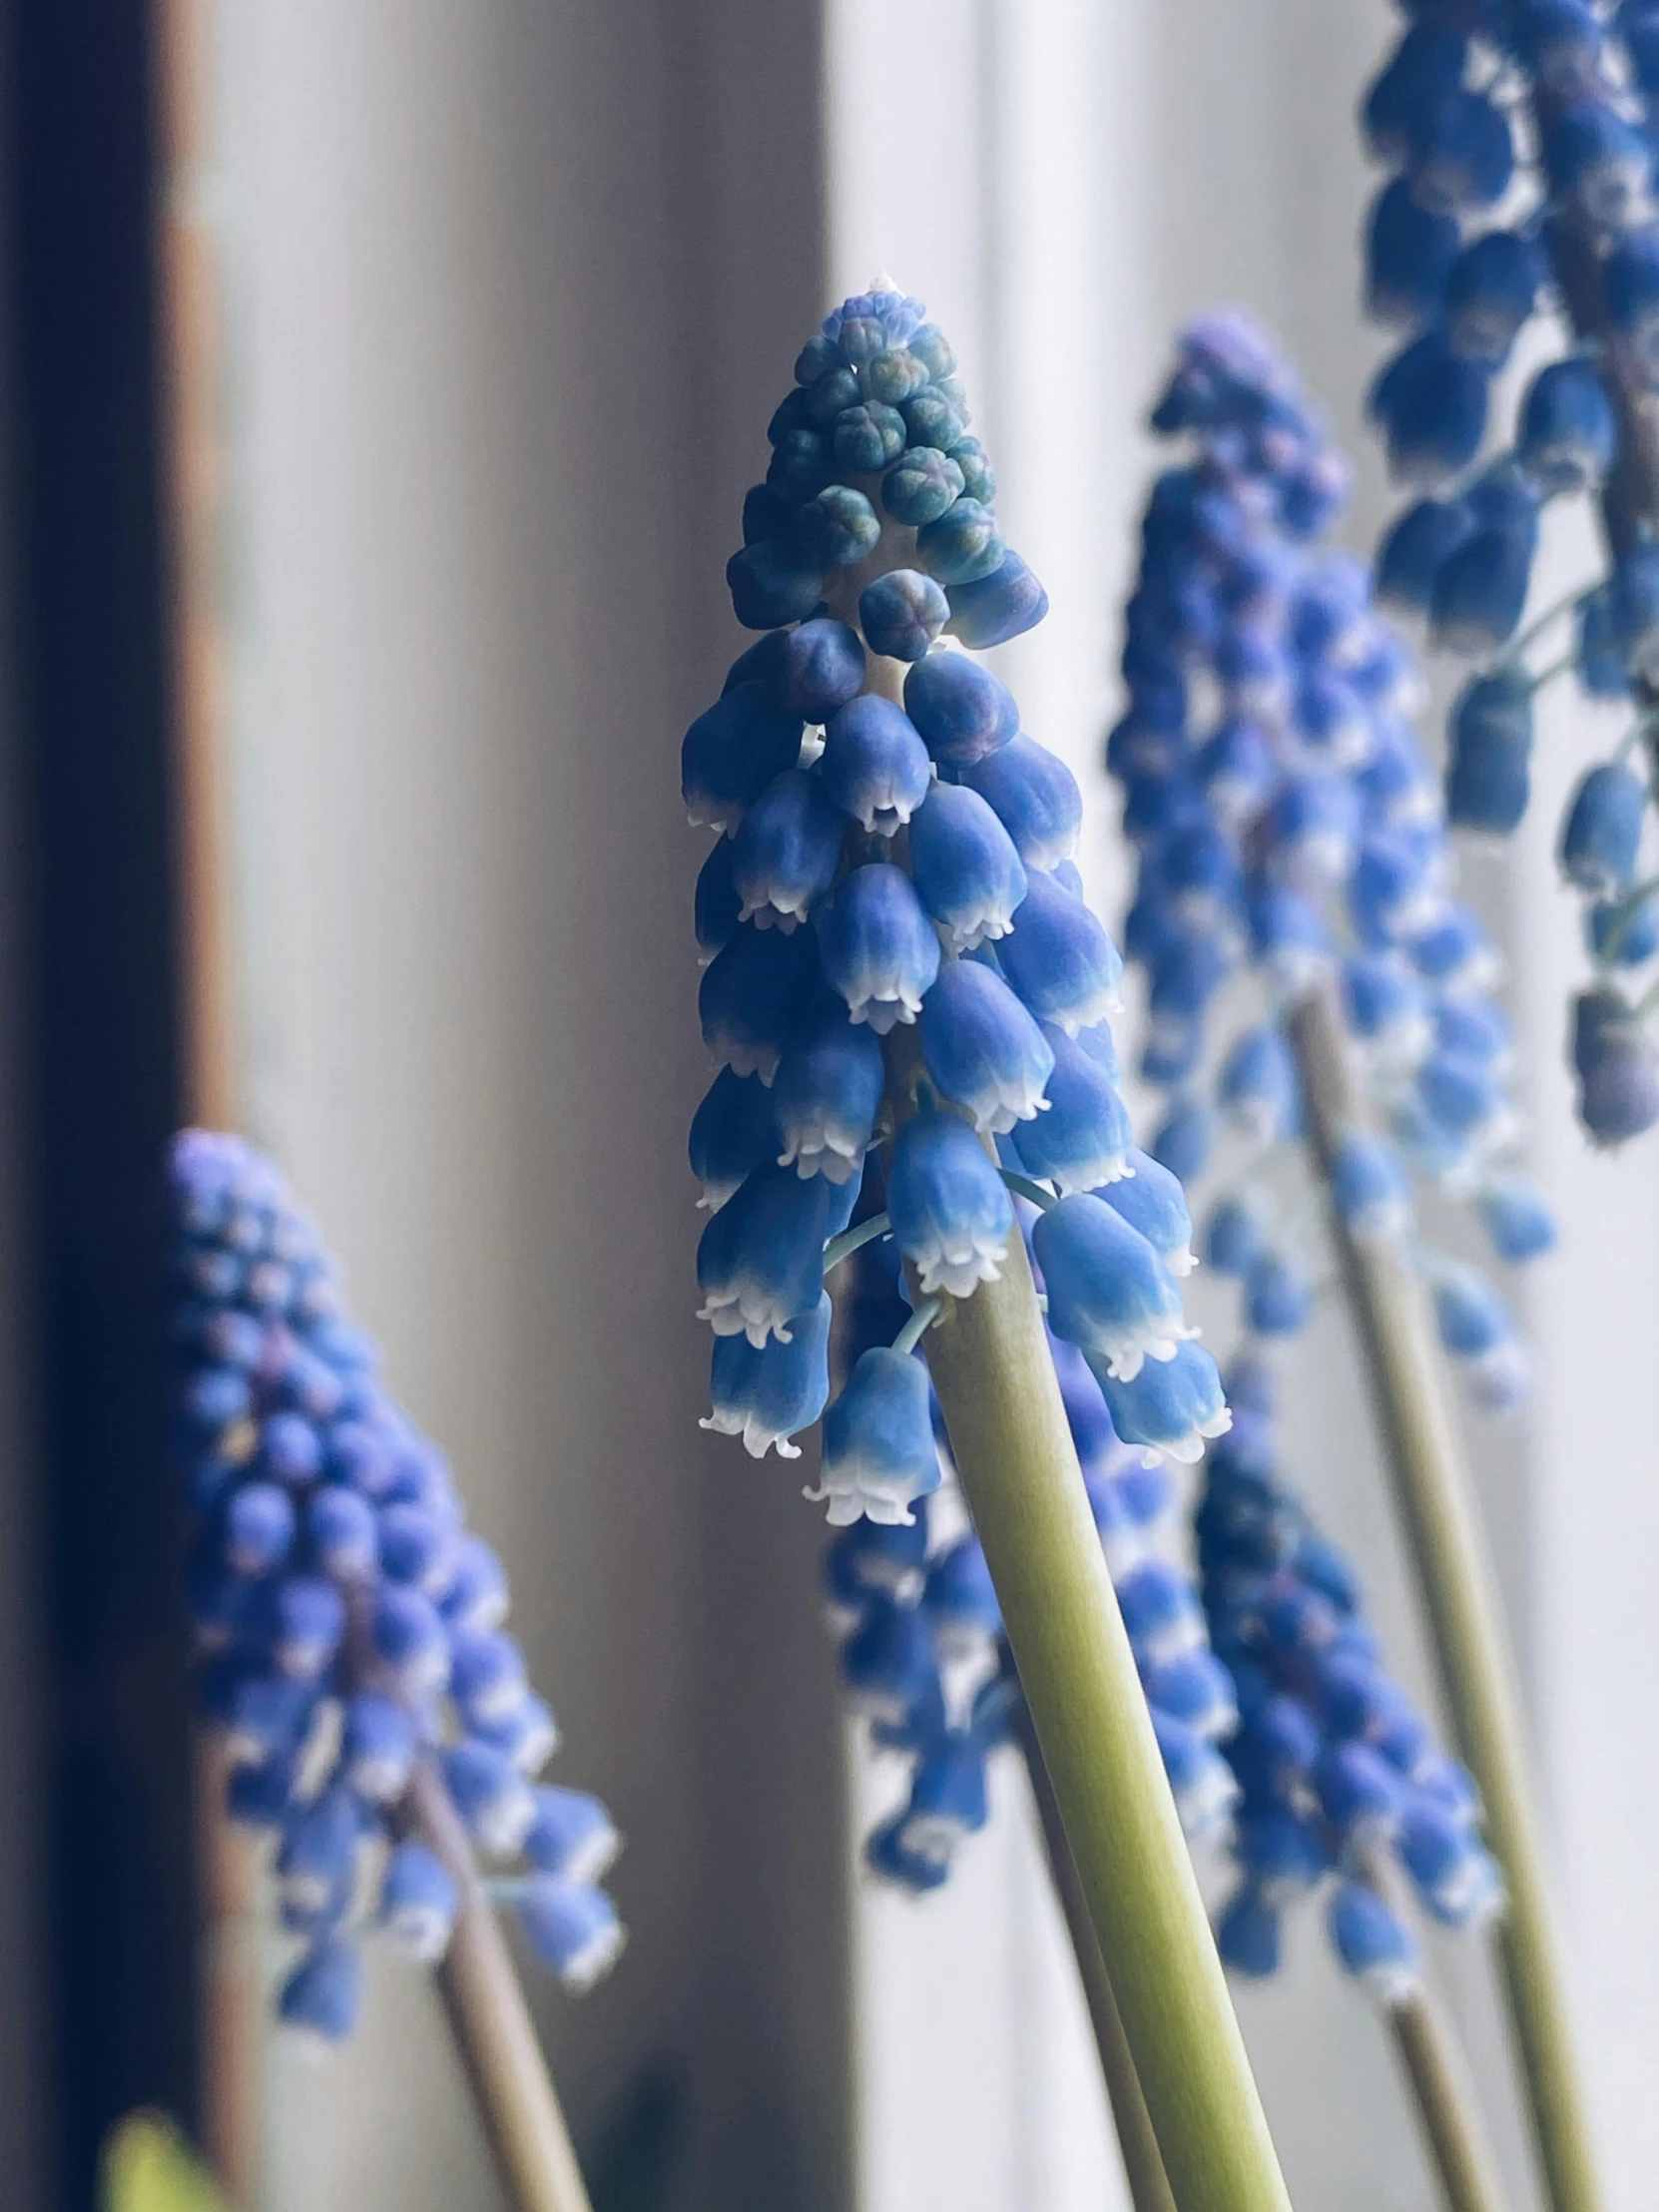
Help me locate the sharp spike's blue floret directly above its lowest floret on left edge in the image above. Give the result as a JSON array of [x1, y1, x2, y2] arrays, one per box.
[[697, 1164, 858, 1350]]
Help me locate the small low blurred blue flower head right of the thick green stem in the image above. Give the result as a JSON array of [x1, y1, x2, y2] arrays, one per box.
[[1195, 1356, 1504, 2004]]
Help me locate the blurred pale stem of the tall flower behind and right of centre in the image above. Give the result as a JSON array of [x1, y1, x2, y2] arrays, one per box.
[[1290, 991, 1601, 2212]]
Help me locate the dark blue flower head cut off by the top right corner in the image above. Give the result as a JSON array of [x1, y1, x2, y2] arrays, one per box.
[[1363, 0, 1659, 1146]]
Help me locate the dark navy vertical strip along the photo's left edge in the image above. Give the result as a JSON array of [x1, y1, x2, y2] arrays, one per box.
[[0, 0, 195, 2212]]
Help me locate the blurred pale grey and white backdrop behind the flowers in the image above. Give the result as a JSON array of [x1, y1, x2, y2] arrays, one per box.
[[0, 0, 1659, 2212]]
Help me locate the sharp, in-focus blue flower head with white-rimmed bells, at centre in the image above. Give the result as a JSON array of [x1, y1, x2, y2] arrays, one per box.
[[682, 287, 1226, 1526]]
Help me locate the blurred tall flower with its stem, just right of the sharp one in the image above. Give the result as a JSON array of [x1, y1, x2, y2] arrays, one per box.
[[1106, 320, 1601, 2212]]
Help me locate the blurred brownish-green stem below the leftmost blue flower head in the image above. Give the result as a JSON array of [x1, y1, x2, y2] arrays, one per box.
[[400, 1761, 591, 2212]]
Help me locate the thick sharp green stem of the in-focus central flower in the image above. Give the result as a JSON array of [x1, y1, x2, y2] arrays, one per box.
[[887, 1052, 1290, 2212]]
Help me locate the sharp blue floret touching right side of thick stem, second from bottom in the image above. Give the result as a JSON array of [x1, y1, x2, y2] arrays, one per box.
[[1031, 1197, 1190, 1380]]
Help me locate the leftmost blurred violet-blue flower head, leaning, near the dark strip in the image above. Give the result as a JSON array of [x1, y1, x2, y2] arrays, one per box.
[[168, 1128, 624, 2041]]
